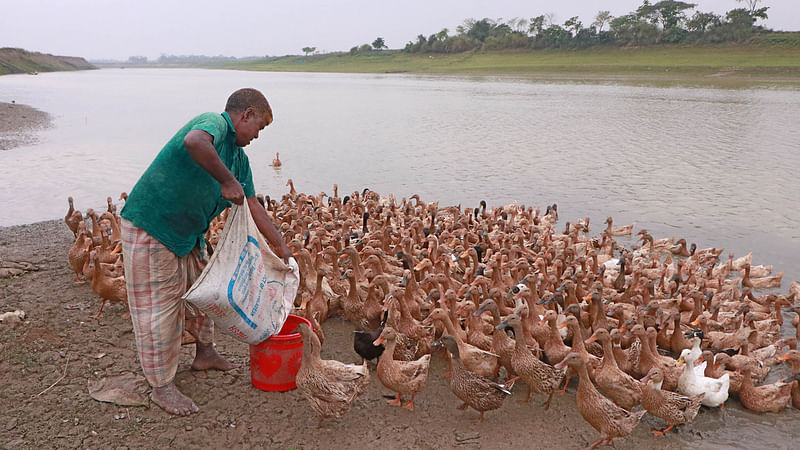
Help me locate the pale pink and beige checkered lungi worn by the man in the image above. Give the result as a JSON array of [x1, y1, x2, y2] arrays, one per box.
[[122, 219, 214, 387]]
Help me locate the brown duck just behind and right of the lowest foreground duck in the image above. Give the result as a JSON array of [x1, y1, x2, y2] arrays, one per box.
[[586, 328, 644, 410]]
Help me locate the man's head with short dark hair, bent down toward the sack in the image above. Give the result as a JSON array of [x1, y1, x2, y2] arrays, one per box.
[[225, 88, 272, 147]]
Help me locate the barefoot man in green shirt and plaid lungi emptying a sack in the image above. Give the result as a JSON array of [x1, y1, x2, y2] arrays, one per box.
[[121, 89, 292, 416]]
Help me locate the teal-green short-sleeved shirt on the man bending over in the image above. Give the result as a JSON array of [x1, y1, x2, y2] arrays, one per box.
[[121, 112, 255, 257]]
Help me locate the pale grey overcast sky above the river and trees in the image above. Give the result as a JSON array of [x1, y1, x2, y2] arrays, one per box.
[[0, 0, 800, 59]]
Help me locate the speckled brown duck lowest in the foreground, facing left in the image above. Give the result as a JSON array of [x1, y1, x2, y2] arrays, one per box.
[[555, 353, 647, 449]]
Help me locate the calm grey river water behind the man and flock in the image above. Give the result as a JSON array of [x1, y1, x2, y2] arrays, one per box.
[[0, 69, 800, 448]]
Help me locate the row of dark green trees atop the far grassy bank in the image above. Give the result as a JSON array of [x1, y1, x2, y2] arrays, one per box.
[[394, 0, 769, 54]]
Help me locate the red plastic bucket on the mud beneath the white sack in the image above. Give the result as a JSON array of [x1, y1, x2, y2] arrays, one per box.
[[250, 314, 311, 392]]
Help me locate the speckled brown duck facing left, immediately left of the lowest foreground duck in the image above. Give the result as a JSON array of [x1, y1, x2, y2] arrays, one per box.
[[495, 313, 564, 409]]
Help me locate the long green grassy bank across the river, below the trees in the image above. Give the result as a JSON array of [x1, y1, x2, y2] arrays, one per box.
[[221, 44, 800, 79]]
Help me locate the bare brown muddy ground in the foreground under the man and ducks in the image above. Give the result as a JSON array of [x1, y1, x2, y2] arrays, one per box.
[[0, 220, 799, 449]]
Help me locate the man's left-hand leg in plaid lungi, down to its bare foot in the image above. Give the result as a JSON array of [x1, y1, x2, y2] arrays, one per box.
[[122, 220, 198, 416]]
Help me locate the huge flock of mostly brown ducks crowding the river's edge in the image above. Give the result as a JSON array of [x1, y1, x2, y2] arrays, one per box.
[[66, 180, 800, 448]]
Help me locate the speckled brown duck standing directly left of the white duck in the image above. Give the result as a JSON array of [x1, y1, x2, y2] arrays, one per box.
[[642, 367, 705, 436]]
